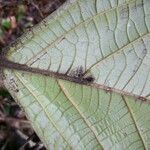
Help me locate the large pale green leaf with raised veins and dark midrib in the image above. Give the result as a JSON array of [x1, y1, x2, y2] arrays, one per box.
[[4, 0, 150, 150]]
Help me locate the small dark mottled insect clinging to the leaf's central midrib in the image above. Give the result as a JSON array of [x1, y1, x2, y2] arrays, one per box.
[[69, 66, 95, 83]]
